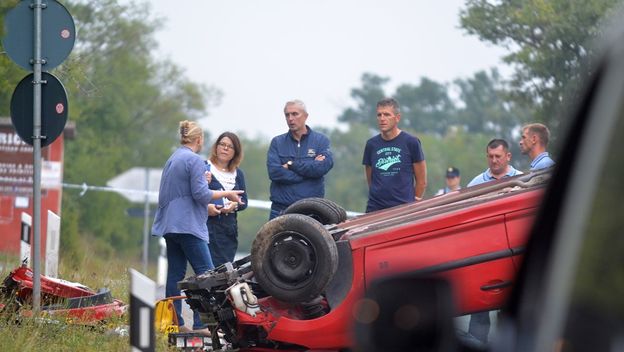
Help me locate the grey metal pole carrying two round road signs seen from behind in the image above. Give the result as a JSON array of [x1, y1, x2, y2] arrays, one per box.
[[2, 0, 76, 313]]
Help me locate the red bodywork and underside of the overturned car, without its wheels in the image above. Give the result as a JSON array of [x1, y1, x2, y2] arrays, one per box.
[[179, 173, 548, 350]]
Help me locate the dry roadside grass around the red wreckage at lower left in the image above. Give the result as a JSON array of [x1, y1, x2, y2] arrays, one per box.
[[0, 253, 179, 352]]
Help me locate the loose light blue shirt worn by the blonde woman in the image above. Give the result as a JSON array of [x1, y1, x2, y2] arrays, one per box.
[[152, 147, 212, 242]]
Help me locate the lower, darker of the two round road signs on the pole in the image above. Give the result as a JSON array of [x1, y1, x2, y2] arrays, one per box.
[[11, 72, 67, 147]]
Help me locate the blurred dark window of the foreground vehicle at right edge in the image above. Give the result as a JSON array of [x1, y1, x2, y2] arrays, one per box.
[[561, 99, 624, 351]]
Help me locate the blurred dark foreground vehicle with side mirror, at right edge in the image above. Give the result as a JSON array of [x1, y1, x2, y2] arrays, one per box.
[[358, 7, 624, 351]]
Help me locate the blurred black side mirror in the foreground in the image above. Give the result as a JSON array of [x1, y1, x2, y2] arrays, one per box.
[[355, 276, 458, 352]]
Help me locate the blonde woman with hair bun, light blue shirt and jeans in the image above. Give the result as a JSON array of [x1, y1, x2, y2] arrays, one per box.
[[152, 120, 243, 334]]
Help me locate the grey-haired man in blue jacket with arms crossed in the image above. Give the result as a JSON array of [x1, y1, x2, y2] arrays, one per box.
[[267, 100, 334, 220]]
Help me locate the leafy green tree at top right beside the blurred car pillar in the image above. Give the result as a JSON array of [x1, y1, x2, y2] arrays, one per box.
[[460, 0, 619, 129]]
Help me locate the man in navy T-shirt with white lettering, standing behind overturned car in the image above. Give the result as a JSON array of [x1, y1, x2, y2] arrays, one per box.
[[362, 98, 427, 213]]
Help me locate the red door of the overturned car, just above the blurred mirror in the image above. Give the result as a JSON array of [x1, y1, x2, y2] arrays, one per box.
[[365, 214, 516, 314]]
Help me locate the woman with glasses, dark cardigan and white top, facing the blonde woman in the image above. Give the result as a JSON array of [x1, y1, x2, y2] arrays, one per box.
[[206, 132, 247, 267]]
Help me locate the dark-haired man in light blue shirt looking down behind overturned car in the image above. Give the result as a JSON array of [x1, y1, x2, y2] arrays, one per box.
[[468, 139, 522, 187]]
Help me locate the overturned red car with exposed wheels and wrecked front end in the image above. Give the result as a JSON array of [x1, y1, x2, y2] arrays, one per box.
[[179, 171, 550, 350]]
